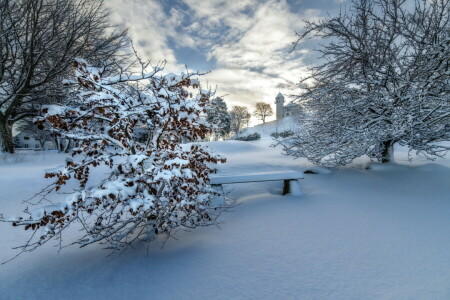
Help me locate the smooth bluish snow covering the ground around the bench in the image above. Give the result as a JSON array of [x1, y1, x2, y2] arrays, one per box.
[[0, 137, 450, 299]]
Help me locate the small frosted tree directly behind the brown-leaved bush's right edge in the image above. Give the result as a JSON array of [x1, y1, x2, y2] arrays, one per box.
[[206, 97, 231, 141]]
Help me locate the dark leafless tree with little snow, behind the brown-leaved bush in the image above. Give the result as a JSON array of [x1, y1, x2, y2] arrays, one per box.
[[0, 0, 127, 153]]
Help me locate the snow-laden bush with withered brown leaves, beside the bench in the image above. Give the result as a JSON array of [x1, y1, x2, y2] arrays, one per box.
[[2, 60, 225, 251]]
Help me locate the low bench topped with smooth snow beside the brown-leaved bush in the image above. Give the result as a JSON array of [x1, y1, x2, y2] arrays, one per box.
[[210, 171, 304, 196]]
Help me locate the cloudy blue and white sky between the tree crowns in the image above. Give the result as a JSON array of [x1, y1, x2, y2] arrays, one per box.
[[106, 0, 349, 122]]
